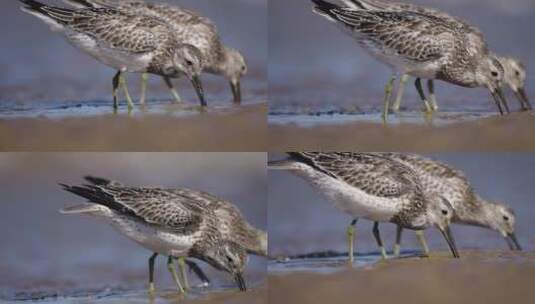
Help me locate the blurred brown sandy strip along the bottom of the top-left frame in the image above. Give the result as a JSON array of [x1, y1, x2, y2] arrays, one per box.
[[0, 104, 267, 152]]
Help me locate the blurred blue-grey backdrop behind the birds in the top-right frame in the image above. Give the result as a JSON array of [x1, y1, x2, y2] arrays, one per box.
[[269, 0, 535, 113]]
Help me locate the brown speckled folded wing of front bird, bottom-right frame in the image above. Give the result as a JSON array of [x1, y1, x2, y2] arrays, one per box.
[[289, 152, 417, 197]]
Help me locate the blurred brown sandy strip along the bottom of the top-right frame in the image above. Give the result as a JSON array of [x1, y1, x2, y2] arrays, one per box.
[[269, 112, 535, 152]]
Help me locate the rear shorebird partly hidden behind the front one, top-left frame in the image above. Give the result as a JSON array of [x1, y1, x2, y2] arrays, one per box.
[[64, 0, 247, 103]]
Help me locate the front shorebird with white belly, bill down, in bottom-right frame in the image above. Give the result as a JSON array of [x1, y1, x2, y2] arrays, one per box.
[[268, 152, 459, 262]]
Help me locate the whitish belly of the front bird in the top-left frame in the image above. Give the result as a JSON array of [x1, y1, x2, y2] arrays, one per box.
[[66, 32, 153, 73]]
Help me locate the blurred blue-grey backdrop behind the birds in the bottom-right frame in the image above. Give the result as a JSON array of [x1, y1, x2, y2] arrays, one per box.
[[268, 153, 535, 256]]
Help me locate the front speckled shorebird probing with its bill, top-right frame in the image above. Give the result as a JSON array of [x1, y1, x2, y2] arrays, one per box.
[[312, 0, 507, 122]]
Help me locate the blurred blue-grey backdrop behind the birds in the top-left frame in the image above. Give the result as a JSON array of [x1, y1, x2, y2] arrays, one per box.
[[0, 0, 267, 116]]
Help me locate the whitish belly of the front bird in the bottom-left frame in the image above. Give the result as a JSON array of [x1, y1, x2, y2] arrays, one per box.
[[111, 215, 195, 256]]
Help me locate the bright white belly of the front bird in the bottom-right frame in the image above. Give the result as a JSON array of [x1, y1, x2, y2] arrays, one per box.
[[311, 175, 401, 222]]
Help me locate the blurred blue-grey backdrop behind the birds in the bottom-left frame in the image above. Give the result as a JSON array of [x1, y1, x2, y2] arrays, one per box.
[[0, 153, 267, 302]]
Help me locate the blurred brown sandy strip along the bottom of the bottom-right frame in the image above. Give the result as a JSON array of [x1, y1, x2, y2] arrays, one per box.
[[269, 251, 535, 304]]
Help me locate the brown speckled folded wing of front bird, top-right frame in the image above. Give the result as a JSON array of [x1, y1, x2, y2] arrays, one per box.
[[314, 0, 455, 62]]
